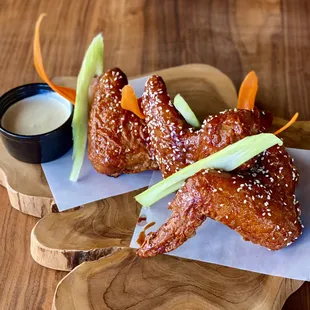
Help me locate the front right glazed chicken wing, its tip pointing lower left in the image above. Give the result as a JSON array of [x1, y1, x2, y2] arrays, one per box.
[[137, 146, 301, 257]]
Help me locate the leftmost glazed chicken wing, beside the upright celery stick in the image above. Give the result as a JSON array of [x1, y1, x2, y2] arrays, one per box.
[[88, 68, 158, 177]]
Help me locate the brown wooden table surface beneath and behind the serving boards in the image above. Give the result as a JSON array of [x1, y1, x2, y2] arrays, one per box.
[[0, 0, 310, 310]]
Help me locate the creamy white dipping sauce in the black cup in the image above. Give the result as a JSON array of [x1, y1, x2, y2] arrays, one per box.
[[1, 92, 72, 136]]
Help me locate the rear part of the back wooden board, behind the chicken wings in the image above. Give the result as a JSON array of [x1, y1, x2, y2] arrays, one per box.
[[53, 63, 237, 117]]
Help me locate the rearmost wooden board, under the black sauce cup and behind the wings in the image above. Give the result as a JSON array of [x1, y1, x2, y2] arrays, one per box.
[[0, 64, 236, 217]]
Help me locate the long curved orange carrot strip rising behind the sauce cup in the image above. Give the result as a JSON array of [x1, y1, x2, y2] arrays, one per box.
[[33, 13, 76, 104]]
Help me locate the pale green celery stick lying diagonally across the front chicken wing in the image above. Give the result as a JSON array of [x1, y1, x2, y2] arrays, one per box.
[[135, 133, 283, 206]]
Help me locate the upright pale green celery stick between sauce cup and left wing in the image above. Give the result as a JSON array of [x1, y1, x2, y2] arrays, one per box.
[[70, 34, 103, 182]]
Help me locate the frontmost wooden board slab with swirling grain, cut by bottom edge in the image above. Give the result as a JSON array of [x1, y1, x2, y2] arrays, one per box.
[[53, 249, 301, 310]]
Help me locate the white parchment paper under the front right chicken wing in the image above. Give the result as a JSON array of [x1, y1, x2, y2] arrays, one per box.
[[130, 149, 310, 281]]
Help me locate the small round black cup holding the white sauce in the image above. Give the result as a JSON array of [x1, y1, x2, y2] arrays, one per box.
[[0, 83, 73, 164]]
